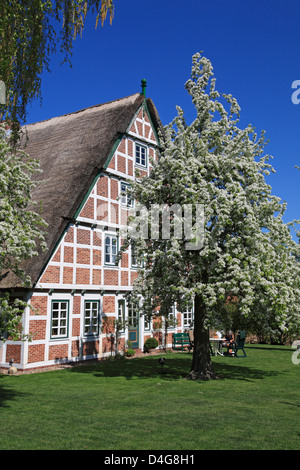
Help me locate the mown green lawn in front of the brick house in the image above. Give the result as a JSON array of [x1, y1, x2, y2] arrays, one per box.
[[0, 345, 300, 451]]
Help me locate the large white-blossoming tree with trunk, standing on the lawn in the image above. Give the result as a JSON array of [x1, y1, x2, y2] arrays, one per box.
[[124, 53, 300, 379]]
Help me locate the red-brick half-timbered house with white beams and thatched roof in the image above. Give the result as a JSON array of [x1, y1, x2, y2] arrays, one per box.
[[0, 84, 190, 370]]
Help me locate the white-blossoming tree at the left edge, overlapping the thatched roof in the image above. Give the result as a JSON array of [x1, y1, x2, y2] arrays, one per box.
[[0, 124, 46, 340]]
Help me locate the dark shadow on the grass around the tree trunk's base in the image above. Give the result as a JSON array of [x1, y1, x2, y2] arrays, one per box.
[[69, 353, 278, 382]]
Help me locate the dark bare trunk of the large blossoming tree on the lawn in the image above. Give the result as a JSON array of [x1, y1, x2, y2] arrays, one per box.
[[187, 294, 217, 380]]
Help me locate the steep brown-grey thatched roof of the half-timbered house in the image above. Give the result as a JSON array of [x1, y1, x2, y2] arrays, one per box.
[[0, 93, 161, 288]]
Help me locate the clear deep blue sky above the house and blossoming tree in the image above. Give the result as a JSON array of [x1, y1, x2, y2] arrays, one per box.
[[27, 0, 300, 239]]
